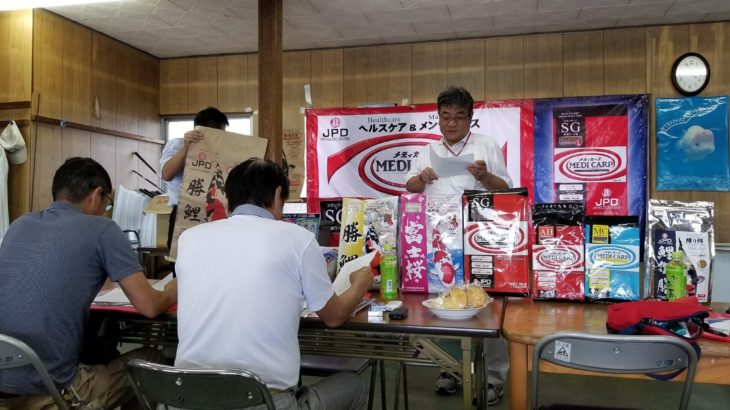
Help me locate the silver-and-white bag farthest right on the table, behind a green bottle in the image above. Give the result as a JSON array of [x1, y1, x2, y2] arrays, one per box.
[[644, 199, 715, 302]]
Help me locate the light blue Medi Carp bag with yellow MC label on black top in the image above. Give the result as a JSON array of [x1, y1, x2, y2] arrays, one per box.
[[585, 216, 641, 300]]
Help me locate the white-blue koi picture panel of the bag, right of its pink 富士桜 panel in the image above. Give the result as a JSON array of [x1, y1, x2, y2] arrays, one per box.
[[426, 195, 464, 293]]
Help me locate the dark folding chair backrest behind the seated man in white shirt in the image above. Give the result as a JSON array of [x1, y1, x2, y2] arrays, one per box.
[[127, 359, 276, 410]]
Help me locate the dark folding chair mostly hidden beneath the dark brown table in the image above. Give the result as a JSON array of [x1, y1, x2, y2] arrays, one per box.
[[299, 354, 385, 410]]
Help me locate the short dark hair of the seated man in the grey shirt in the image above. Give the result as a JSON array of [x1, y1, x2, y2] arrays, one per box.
[[51, 157, 112, 202]]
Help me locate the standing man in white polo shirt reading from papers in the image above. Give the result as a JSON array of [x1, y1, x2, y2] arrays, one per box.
[[406, 87, 512, 406]]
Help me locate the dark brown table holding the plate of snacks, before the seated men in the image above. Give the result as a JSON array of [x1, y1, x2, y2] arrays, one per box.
[[99, 294, 504, 410]]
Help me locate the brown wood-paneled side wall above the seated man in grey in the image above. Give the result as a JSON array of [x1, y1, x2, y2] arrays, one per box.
[[29, 10, 159, 211]]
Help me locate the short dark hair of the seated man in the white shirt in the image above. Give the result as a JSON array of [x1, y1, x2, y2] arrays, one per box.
[[225, 158, 289, 212]]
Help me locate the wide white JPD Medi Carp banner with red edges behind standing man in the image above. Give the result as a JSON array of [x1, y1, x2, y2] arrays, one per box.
[[306, 100, 533, 212]]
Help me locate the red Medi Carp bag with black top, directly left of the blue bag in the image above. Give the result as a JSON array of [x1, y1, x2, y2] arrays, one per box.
[[532, 202, 585, 300]]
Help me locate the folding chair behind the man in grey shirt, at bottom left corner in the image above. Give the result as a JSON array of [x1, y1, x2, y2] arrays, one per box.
[[0, 334, 68, 410]]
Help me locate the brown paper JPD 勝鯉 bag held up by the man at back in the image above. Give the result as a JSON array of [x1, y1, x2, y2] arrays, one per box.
[[170, 126, 268, 260]]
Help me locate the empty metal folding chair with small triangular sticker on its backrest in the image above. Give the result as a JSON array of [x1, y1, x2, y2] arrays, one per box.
[[530, 332, 697, 409]]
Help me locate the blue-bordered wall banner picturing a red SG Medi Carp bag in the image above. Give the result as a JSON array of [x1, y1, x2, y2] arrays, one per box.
[[534, 95, 648, 226]]
